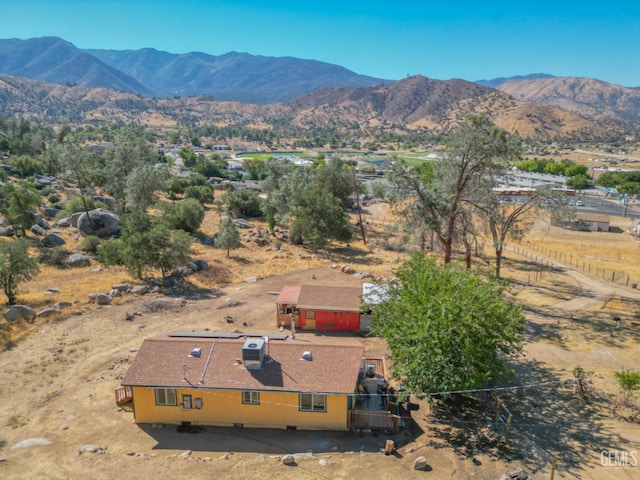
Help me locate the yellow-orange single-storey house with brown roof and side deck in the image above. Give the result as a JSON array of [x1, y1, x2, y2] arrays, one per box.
[[116, 332, 400, 430]]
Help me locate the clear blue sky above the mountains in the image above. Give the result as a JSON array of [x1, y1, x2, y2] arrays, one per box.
[[0, 0, 640, 87]]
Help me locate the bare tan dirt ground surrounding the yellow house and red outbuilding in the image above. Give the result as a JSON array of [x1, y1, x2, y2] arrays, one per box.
[[0, 207, 640, 480]]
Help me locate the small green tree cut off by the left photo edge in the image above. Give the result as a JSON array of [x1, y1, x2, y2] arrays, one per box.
[[0, 239, 39, 305]]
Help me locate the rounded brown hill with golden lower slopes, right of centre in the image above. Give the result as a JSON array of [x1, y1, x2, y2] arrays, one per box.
[[286, 75, 633, 140]]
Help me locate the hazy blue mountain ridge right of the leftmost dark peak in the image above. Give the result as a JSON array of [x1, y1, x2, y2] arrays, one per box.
[[86, 48, 389, 103]]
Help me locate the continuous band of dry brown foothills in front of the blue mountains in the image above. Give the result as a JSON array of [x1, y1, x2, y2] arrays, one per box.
[[0, 75, 634, 140]]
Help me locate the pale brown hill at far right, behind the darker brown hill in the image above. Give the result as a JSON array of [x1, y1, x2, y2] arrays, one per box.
[[499, 77, 640, 124]]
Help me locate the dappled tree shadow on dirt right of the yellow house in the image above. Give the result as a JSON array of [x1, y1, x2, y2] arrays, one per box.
[[424, 361, 628, 477]]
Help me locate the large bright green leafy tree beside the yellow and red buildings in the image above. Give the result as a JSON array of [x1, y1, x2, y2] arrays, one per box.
[[363, 252, 525, 393]]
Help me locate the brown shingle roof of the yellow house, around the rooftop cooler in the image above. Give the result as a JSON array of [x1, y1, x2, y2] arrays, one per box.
[[122, 336, 364, 393]]
